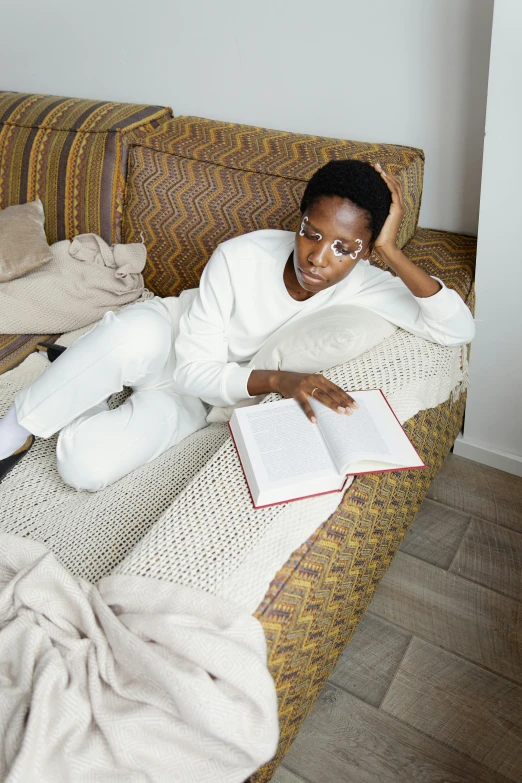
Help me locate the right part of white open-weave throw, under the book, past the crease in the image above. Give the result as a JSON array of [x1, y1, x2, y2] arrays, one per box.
[[113, 329, 468, 612]]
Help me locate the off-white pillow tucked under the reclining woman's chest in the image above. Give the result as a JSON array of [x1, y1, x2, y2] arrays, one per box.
[[207, 305, 397, 422]]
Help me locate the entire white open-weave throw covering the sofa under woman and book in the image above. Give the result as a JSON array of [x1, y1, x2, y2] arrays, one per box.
[[0, 329, 468, 611]]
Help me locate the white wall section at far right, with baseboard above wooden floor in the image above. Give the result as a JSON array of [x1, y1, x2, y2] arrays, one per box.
[[454, 0, 522, 476]]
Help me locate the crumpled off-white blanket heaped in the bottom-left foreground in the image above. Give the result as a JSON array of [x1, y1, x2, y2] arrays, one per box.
[[0, 535, 278, 783]]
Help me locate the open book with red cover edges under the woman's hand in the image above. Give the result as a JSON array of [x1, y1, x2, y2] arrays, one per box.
[[229, 389, 426, 508]]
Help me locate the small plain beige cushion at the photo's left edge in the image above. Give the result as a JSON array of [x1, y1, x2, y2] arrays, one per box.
[[0, 199, 53, 283]]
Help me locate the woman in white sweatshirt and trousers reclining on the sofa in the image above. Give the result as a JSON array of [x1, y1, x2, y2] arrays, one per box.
[[0, 160, 474, 491]]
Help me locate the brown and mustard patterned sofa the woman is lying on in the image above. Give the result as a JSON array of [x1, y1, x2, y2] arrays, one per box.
[[0, 92, 476, 783]]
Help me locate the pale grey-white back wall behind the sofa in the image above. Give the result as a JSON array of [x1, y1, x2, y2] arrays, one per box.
[[0, 0, 493, 233]]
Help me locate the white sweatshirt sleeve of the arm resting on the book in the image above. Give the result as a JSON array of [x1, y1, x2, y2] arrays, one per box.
[[174, 246, 252, 406]]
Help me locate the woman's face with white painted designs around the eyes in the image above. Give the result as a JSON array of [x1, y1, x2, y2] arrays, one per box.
[[294, 196, 371, 294]]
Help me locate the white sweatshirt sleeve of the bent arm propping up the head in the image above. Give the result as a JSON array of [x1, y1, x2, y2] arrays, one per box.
[[353, 265, 475, 346]]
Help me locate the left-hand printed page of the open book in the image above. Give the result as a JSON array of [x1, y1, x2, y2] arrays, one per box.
[[241, 400, 339, 484]]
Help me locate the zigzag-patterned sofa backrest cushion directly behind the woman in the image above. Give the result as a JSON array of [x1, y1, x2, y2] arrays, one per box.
[[124, 117, 424, 296]]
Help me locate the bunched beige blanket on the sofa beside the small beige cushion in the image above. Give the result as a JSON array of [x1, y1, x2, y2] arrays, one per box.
[[0, 234, 147, 334]]
